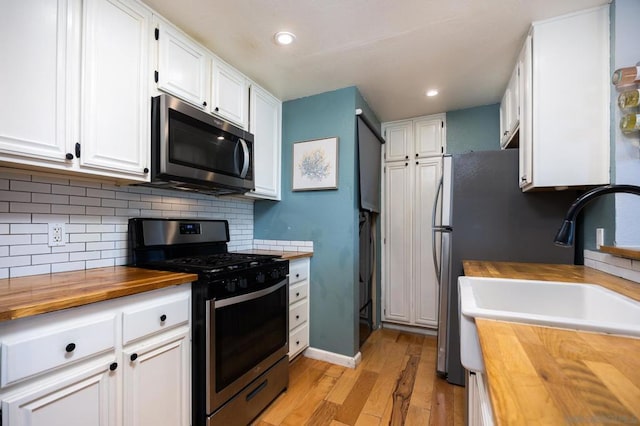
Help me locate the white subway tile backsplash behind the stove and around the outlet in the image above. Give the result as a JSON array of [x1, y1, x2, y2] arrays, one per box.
[[0, 172, 254, 279]]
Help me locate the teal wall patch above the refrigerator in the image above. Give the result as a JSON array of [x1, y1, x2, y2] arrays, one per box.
[[447, 104, 500, 154]]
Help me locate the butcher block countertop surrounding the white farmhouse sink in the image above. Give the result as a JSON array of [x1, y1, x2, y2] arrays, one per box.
[[464, 261, 640, 425]]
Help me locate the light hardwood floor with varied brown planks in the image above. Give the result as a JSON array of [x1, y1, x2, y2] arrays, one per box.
[[253, 329, 464, 426]]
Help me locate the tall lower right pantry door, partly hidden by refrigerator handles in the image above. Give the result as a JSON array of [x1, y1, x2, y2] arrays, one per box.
[[412, 157, 442, 327]]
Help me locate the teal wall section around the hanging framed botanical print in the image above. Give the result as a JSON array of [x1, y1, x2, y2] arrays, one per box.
[[254, 87, 375, 356]]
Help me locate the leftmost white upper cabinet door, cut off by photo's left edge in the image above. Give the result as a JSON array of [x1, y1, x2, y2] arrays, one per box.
[[0, 0, 80, 163]]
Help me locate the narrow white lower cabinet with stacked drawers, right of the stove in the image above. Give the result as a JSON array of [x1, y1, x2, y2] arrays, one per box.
[[289, 257, 310, 359]]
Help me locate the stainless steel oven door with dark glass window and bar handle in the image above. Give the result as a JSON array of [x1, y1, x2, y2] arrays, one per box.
[[206, 278, 289, 414]]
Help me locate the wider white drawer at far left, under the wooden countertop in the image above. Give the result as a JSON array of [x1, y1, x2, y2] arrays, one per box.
[[0, 315, 116, 387]]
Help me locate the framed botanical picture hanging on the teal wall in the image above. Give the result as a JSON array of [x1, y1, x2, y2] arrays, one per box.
[[292, 138, 338, 191]]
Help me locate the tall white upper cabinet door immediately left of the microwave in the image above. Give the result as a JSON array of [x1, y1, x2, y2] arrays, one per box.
[[80, 0, 151, 181]]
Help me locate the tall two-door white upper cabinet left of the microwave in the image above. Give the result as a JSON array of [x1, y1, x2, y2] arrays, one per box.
[[0, 0, 151, 181]]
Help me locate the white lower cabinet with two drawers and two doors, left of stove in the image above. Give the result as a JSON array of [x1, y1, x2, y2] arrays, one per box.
[[0, 285, 191, 426]]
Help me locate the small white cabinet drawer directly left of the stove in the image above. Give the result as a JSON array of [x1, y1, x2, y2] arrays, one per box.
[[122, 295, 189, 345]]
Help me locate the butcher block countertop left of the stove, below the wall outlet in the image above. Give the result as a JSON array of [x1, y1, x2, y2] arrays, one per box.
[[0, 266, 197, 321]]
